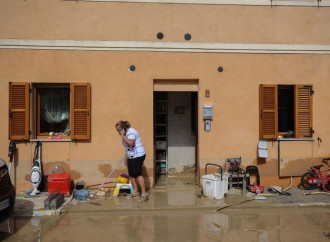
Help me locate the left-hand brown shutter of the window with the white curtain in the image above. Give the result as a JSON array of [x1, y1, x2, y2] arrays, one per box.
[[9, 82, 30, 140]]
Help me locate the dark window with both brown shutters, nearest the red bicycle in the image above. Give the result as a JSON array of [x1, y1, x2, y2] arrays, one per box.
[[259, 85, 313, 139]]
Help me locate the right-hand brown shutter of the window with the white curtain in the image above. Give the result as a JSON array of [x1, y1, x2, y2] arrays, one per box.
[[70, 83, 91, 140]]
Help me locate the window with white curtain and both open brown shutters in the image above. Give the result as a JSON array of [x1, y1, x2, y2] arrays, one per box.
[[9, 83, 90, 140]]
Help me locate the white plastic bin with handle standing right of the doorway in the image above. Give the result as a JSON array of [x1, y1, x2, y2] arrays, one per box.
[[202, 173, 228, 199]]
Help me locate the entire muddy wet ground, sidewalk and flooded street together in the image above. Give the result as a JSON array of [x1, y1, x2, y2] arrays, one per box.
[[0, 177, 330, 242]]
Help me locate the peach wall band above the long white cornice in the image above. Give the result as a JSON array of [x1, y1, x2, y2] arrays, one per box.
[[0, 0, 330, 44]]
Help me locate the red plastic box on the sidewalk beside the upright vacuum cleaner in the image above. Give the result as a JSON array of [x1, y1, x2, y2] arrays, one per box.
[[48, 173, 71, 197]]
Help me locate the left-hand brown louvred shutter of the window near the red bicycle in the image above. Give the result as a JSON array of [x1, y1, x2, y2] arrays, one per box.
[[259, 85, 278, 139]]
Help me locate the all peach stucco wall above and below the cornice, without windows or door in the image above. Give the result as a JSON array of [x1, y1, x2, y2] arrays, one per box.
[[0, 0, 330, 190]]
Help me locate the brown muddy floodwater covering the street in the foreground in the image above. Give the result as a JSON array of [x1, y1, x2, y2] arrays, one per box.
[[0, 207, 330, 242]]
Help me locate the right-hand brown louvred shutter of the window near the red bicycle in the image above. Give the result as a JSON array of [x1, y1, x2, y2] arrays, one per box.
[[295, 85, 313, 138]]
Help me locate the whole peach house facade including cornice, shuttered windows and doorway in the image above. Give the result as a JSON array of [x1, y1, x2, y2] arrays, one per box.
[[0, 0, 330, 191]]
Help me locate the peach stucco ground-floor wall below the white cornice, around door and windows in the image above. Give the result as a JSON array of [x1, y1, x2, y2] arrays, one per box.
[[0, 50, 330, 190]]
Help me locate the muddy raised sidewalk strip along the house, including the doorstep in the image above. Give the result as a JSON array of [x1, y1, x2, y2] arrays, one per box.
[[5, 177, 330, 217]]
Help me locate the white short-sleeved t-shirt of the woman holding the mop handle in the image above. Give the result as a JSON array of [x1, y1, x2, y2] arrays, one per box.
[[121, 128, 146, 159]]
